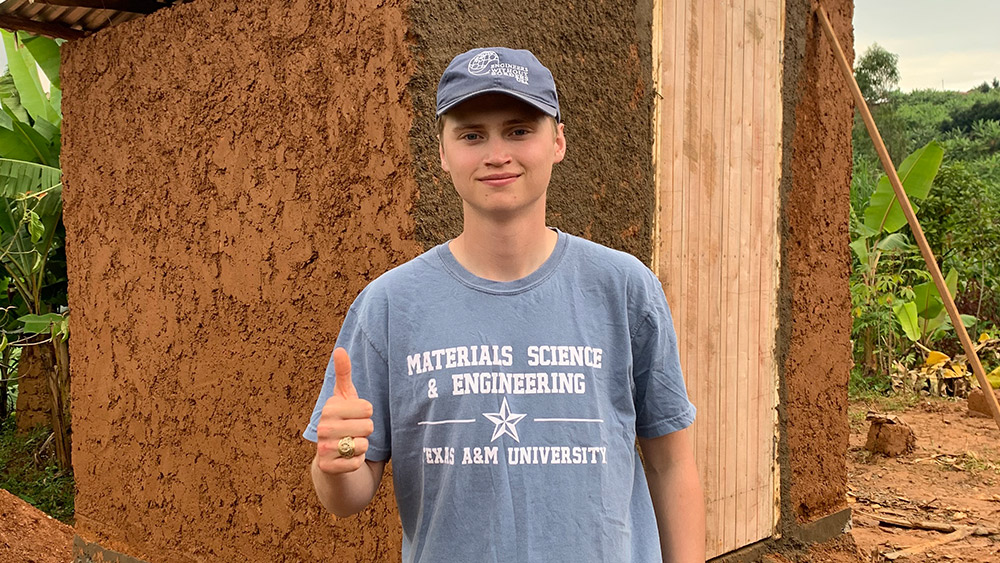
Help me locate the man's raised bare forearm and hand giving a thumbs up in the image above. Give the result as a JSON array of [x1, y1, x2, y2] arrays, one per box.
[[310, 348, 385, 516]]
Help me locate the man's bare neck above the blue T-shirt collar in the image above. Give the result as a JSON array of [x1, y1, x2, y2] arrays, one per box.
[[448, 210, 559, 281]]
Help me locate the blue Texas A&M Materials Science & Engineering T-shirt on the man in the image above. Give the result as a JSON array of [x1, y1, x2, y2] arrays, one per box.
[[303, 232, 695, 563]]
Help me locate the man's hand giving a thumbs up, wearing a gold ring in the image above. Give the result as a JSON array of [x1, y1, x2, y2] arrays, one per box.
[[316, 348, 375, 474]]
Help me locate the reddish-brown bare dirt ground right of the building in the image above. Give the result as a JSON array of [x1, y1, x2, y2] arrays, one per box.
[[848, 397, 1000, 563]]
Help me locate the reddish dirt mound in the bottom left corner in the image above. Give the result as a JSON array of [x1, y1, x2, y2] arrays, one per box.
[[0, 489, 73, 563]]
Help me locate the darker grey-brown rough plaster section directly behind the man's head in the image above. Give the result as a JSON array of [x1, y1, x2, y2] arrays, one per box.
[[409, 0, 655, 263]]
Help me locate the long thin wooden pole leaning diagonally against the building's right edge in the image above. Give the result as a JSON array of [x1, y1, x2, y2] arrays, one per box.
[[813, 2, 1000, 428]]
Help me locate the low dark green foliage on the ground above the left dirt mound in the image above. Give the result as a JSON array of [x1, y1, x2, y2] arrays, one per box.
[[0, 417, 74, 525]]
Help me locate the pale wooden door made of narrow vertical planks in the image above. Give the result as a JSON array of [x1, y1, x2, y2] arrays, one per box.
[[653, 0, 784, 557]]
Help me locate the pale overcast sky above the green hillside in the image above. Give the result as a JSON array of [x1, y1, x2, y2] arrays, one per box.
[[854, 0, 1000, 92]]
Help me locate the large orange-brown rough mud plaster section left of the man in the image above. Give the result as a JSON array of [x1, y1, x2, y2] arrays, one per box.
[[62, 0, 420, 562]]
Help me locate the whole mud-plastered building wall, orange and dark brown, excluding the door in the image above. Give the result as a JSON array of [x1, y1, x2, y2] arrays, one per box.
[[63, 0, 851, 562]]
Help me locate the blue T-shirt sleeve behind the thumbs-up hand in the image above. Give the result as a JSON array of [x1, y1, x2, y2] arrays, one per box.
[[302, 294, 392, 461]]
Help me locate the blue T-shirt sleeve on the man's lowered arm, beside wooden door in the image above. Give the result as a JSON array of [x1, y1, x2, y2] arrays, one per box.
[[631, 272, 696, 438]]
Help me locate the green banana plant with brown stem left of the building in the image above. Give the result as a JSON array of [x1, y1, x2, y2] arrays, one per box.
[[0, 31, 71, 469]]
